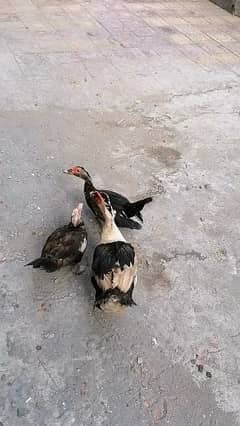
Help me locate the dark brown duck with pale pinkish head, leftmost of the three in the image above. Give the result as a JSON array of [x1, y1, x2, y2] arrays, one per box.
[[25, 203, 87, 272]]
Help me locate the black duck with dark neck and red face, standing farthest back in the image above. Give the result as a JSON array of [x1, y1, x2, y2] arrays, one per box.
[[64, 166, 152, 229]]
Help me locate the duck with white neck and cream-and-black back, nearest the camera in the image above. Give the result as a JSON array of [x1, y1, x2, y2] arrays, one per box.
[[90, 191, 137, 311]]
